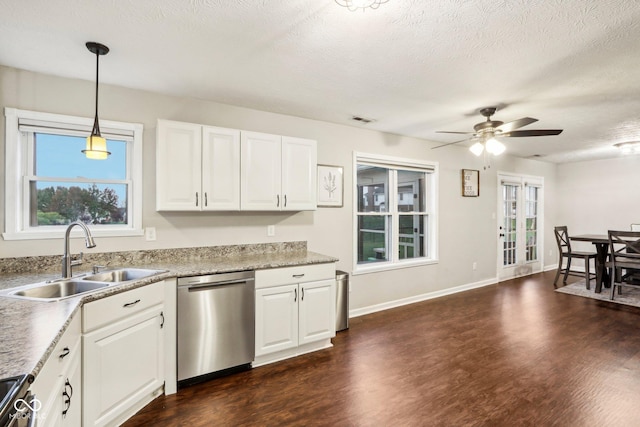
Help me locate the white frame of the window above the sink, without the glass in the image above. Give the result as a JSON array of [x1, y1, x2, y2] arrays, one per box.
[[2, 108, 143, 240]]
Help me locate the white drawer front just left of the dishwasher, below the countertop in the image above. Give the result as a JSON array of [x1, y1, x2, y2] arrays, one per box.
[[82, 282, 164, 332]]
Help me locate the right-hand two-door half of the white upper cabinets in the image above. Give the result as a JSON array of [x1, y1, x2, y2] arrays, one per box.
[[241, 132, 317, 211]]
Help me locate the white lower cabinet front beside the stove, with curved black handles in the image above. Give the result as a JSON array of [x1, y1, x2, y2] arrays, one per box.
[[30, 315, 82, 427]]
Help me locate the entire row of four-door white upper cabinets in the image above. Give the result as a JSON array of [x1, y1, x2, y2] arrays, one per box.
[[156, 120, 317, 211]]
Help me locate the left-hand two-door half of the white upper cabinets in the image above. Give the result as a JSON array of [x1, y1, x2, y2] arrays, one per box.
[[156, 120, 240, 211]]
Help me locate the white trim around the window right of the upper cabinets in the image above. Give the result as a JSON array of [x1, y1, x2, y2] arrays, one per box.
[[351, 151, 440, 276]]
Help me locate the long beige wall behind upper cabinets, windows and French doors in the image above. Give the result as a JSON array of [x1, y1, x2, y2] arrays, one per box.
[[0, 66, 556, 309]]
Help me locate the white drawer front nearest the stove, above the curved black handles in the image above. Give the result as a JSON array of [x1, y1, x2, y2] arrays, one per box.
[[31, 313, 81, 401]]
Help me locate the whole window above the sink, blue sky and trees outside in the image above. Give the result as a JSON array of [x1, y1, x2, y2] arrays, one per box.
[[3, 108, 142, 240]]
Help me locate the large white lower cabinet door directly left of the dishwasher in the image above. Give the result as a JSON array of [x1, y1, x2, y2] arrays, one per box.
[[82, 306, 164, 427]]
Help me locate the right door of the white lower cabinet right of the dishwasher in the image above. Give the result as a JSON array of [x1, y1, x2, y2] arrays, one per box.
[[298, 280, 336, 345]]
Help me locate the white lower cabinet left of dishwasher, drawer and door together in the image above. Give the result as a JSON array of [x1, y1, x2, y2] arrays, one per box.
[[82, 282, 165, 427]]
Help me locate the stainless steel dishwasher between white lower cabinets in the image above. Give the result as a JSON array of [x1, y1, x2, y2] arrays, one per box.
[[178, 271, 255, 383]]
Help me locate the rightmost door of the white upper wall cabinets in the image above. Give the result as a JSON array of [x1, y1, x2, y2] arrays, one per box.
[[282, 136, 317, 211]]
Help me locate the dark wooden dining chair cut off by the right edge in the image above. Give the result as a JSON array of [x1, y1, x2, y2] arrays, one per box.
[[606, 230, 640, 300]]
